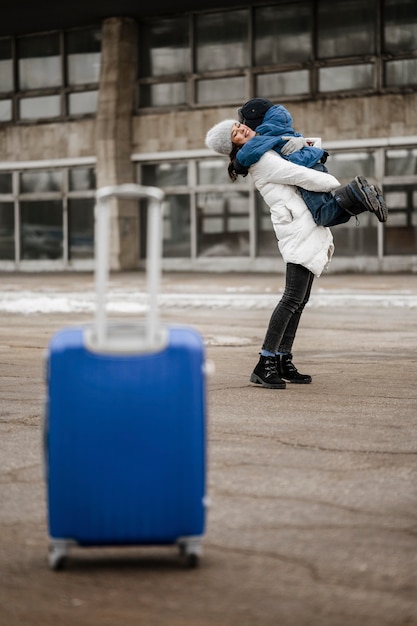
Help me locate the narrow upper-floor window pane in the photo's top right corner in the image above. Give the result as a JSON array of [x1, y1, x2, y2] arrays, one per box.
[[384, 0, 417, 52]]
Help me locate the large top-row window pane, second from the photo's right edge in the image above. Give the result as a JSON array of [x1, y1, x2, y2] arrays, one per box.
[[317, 0, 376, 59]]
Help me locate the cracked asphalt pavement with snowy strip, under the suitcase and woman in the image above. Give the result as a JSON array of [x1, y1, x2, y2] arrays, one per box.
[[0, 272, 417, 626]]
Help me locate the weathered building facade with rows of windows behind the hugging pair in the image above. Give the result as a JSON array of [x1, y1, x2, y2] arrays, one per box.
[[0, 0, 417, 272]]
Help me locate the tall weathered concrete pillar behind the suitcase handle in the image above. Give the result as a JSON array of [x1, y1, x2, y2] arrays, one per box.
[[96, 17, 139, 270]]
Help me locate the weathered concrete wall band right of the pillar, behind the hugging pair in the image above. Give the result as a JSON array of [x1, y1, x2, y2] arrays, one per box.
[[132, 93, 417, 152]]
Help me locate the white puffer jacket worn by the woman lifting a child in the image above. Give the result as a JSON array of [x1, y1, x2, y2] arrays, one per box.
[[249, 150, 340, 276]]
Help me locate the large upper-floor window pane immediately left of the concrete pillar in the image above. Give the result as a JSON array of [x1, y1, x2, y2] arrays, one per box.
[[66, 28, 101, 85]]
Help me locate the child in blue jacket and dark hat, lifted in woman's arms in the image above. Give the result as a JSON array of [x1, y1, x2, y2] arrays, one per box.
[[234, 98, 388, 226]]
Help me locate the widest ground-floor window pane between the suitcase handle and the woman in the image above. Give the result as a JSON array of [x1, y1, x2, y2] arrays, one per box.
[[197, 191, 249, 257]]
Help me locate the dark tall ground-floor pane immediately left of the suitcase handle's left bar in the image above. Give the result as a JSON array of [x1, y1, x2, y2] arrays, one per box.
[[68, 198, 95, 259]]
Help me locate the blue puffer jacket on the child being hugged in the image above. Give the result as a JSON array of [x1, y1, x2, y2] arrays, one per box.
[[236, 104, 325, 167]]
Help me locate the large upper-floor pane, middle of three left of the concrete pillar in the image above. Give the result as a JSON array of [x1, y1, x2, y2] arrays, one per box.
[[17, 33, 62, 90]]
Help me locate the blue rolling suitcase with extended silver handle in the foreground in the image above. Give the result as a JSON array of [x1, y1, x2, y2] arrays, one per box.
[[44, 185, 206, 569]]
